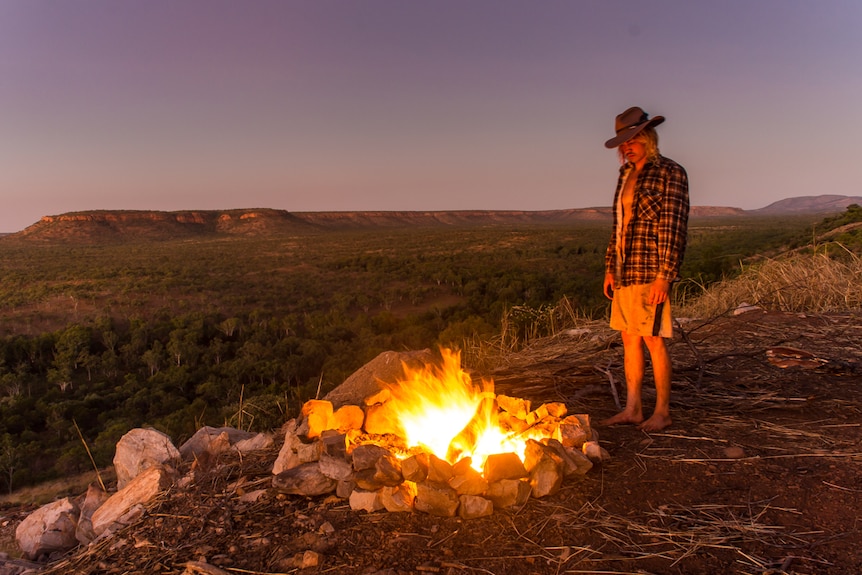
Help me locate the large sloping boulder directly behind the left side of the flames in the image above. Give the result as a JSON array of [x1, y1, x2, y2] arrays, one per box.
[[324, 349, 434, 412]]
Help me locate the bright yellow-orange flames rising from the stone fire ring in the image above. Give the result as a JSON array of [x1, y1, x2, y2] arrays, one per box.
[[389, 349, 542, 471]]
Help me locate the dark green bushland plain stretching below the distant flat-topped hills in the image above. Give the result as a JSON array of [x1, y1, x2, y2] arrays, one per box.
[[0, 211, 850, 496]]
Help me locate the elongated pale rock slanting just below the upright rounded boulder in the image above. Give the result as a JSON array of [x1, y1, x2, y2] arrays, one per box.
[[91, 465, 175, 537]]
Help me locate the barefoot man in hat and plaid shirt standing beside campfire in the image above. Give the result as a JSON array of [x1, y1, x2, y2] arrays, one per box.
[[603, 107, 689, 431]]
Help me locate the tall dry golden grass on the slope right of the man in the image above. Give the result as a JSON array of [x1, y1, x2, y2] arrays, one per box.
[[675, 244, 862, 318]]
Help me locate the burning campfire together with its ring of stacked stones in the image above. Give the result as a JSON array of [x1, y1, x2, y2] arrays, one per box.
[[273, 350, 607, 518]]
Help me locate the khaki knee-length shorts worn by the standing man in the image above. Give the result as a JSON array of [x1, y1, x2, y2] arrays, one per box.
[[611, 284, 673, 338]]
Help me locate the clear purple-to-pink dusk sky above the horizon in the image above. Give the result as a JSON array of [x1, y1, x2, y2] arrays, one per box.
[[0, 0, 862, 232]]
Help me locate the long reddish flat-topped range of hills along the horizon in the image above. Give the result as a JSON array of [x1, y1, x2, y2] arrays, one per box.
[[5, 195, 862, 243]]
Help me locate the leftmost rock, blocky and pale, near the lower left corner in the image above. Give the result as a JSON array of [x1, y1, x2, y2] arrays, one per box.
[[15, 497, 80, 559]]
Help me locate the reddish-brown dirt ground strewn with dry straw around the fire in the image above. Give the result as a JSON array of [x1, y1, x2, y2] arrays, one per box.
[[0, 311, 862, 575]]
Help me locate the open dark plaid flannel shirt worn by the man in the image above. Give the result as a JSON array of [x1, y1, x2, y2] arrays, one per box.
[[605, 156, 689, 287]]
